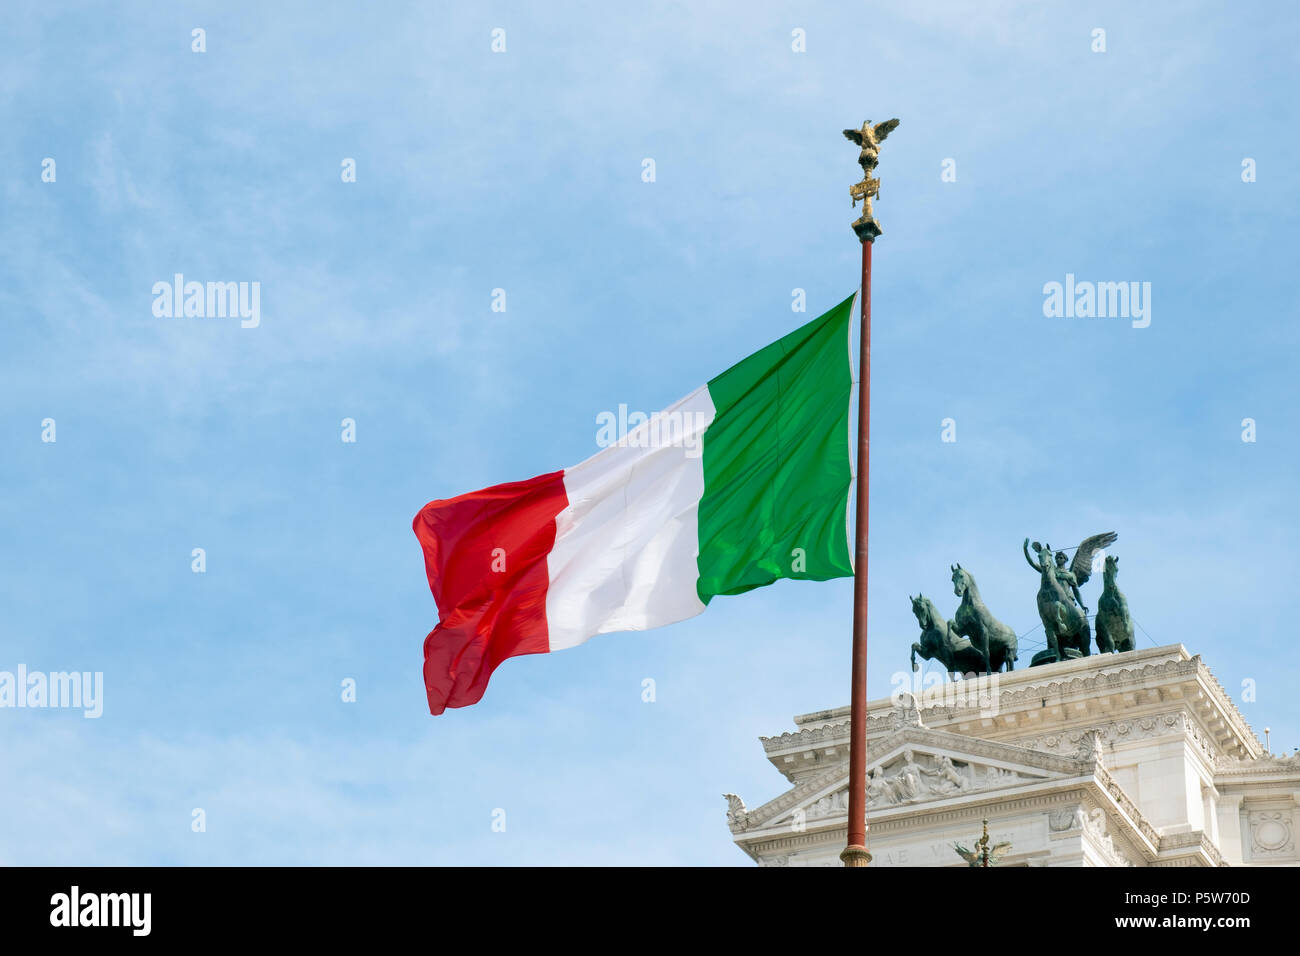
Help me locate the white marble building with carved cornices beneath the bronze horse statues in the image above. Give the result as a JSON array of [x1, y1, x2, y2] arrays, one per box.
[[727, 644, 1300, 866]]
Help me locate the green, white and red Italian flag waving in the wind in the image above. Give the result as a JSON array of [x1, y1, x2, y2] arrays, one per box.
[[413, 295, 854, 714]]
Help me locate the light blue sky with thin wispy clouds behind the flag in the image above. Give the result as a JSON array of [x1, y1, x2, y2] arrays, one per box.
[[0, 3, 1300, 865]]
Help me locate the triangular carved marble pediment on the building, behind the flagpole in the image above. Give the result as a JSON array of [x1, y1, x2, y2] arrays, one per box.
[[728, 727, 1095, 831]]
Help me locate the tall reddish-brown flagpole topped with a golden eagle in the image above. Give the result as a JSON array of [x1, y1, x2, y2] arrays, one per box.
[[840, 120, 898, 866]]
